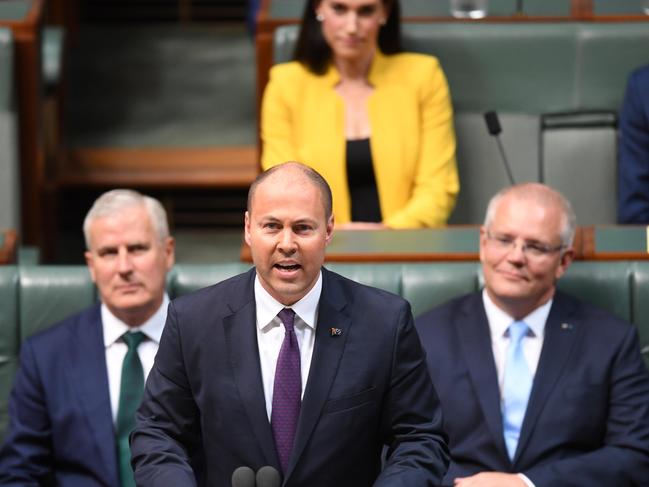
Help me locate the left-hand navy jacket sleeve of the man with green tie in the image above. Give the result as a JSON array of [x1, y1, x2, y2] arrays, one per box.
[[0, 340, 53, 487]]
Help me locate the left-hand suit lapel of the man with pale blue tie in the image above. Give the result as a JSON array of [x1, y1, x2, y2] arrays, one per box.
[[455, 293, 507, 458]]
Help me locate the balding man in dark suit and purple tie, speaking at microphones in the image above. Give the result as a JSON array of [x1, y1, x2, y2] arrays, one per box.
[[131, 163, 447, 487]]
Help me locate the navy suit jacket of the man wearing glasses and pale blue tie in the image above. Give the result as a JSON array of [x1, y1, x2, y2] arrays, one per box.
[[417, 292, 649, 487]]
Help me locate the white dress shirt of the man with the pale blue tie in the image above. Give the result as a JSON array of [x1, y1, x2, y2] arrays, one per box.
[[482, 289, 552, 487]]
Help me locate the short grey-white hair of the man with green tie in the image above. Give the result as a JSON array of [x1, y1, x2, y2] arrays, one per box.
[[83, 189, 169, 250]]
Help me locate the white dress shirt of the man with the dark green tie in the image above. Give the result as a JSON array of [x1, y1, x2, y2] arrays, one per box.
[[101, 294, 169, 422]]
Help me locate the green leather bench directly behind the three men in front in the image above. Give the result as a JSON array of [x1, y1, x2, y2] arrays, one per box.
[[0, 261, 649, 440]]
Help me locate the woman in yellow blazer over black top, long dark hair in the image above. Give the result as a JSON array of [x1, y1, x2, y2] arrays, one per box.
[[261, 0, 459, 228]]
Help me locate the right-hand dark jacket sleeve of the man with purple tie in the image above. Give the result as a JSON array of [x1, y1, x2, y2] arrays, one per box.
[[374, 305, 449, 487]]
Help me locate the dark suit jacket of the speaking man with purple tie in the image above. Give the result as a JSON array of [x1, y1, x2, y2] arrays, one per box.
[[131, 269, 448, 487]]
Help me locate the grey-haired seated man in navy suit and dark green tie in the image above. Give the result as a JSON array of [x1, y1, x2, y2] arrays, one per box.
[[0, 190, 174, 487]]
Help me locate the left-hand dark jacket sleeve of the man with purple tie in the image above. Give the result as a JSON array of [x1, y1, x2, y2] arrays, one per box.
[[131, 303, 200, 487]]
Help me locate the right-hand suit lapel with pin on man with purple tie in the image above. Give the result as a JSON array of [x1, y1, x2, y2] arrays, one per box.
[[286, 268, 352, 478]]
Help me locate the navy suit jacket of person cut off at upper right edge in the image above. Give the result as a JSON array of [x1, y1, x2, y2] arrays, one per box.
[[618, 65, 649, 224]]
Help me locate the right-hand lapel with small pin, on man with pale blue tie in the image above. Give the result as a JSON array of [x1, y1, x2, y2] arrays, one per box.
[[514, 292, 580, 463]]
